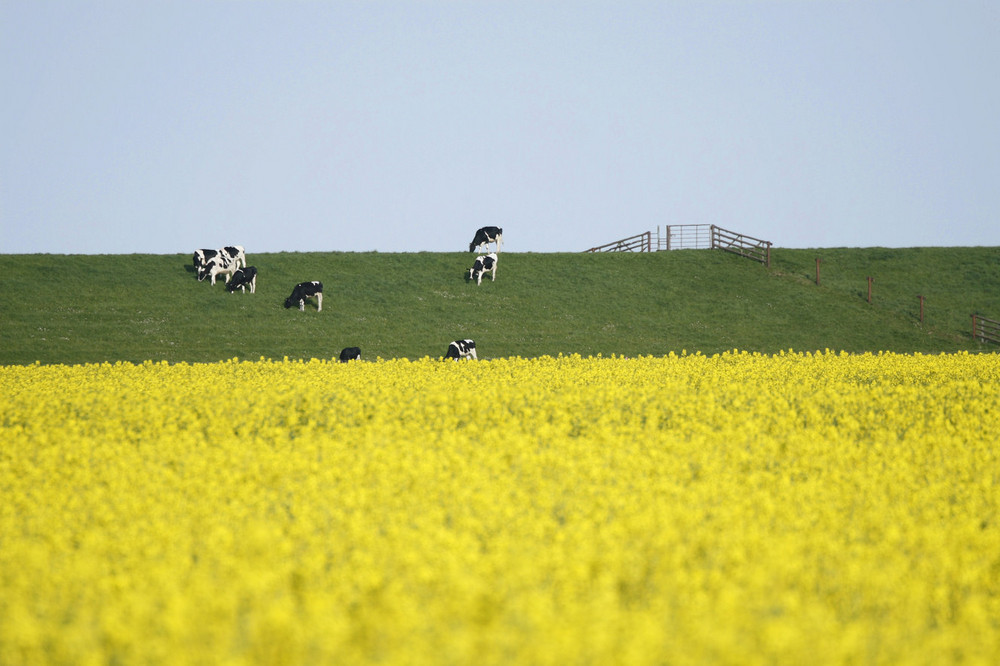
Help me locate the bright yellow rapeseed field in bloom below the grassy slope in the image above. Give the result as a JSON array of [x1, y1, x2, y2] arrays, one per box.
[[0, 351, 1000, 666]]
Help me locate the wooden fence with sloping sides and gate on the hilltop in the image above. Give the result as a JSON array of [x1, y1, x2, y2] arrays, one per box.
[[587, 224, 771, 266]]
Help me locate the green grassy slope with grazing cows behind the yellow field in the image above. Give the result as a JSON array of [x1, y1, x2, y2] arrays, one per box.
[[0, 248, 1000, 365]]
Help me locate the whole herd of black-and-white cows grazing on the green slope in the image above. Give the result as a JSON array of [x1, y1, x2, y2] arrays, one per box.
[[192, 227, 503, 362]]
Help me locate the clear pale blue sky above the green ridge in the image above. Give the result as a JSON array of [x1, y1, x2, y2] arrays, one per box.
[[0, 0, 1000, 255]]
